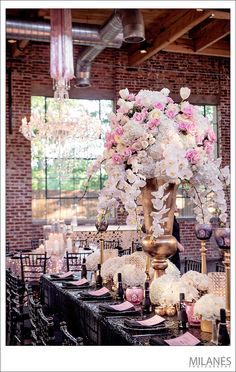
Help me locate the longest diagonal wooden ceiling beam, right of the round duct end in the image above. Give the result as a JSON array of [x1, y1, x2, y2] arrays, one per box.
[[129, 9, 212, 66]]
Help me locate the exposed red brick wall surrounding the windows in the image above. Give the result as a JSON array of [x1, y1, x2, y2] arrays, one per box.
[[6, 43, 230, 258]]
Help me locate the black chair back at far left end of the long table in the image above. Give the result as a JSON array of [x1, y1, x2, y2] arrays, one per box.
[[20, 252, 47, 282]]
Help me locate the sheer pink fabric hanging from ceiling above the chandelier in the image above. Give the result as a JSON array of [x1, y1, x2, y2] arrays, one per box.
[[50, 9, 74, 96]]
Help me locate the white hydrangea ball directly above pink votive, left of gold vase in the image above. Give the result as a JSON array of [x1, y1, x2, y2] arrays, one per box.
[[113, 264, 146, 287]]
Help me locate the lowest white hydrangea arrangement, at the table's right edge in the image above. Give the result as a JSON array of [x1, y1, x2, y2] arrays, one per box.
[[194, 293, 225, 320]]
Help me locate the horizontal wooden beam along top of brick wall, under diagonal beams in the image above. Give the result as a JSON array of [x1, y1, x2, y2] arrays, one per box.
[[163, 38, 230, 57]]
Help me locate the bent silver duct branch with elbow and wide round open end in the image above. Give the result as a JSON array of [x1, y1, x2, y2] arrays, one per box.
[[75, 9, 145, 88]]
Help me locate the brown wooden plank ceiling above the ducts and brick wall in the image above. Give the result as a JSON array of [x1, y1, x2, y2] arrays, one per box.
[[7, 9, 230, 61]]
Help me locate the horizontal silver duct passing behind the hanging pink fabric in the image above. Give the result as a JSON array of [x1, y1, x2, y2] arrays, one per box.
[[6, 19, 123, 48]]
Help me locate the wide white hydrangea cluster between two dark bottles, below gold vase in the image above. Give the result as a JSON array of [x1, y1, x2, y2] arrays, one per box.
[[150, 274, 199, 306]]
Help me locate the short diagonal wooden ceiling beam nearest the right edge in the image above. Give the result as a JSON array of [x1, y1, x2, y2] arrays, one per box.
[[195, 19, 230, 52]]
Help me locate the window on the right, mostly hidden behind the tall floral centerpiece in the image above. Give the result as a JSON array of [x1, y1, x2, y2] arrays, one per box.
[[176, 105, 218, 218]]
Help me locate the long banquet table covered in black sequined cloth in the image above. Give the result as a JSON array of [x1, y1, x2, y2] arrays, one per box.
[[41, 275, 213, 346]]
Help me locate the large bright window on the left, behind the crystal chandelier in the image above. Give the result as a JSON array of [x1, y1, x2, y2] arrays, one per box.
[[31, 96, 115, 223]]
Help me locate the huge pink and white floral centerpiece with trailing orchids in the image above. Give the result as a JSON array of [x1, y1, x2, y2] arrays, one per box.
[[88, 88, 227, 238]]
